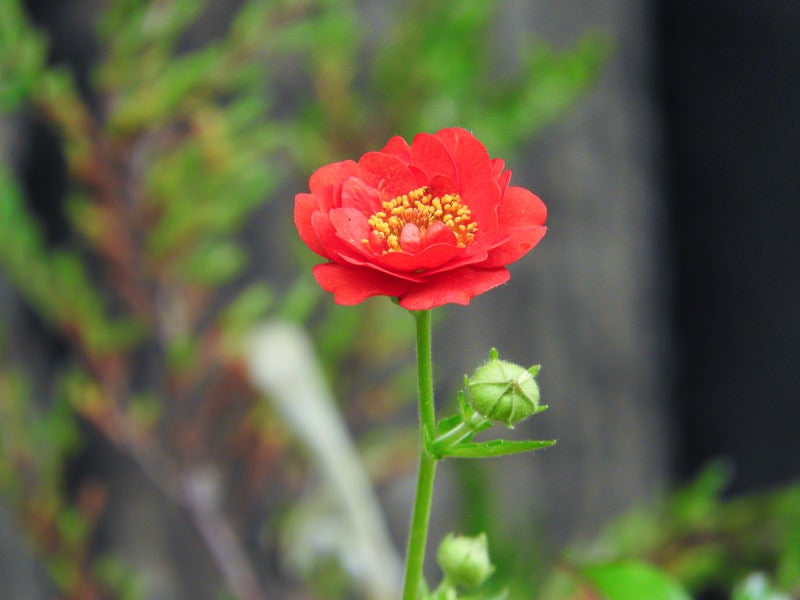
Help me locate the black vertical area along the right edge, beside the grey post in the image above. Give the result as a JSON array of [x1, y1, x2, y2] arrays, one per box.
[[654, 0, 800, 489]]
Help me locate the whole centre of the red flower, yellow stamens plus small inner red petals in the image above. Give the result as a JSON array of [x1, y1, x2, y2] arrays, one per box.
[[361, 186, 478, 254]]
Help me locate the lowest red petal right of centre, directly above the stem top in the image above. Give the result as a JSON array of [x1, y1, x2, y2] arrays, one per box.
[[400, 267, 510, 310]]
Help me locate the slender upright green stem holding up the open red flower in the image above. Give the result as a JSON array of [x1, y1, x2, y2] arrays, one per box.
[[403, 310, 436, 600]]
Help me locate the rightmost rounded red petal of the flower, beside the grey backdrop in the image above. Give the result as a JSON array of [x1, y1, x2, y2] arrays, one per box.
[[484, 186, 547, 267]]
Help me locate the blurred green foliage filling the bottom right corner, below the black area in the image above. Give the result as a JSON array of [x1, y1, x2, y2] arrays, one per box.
[[542, 462, 800, 600]]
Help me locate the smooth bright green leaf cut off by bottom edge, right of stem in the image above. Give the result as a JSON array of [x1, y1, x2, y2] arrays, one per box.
[[583, 561, 690, 600]]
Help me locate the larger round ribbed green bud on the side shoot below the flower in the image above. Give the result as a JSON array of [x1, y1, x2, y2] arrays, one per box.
[[466, 348, 545, 427]]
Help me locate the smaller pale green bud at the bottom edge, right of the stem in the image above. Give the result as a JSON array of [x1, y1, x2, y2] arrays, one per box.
[[436, 533, 494, 588]]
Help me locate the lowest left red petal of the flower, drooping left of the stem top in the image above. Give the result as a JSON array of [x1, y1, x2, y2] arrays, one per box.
[[314, 263, 409, 306]]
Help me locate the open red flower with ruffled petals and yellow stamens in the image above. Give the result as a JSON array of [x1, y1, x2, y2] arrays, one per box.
[[294, 128, 547, 310]]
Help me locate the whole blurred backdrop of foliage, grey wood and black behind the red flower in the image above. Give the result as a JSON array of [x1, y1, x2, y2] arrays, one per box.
[[0, 0, 800, 600]]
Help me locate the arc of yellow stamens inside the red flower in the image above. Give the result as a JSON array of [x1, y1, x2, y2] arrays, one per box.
[[362, 186, 478, 254]]
